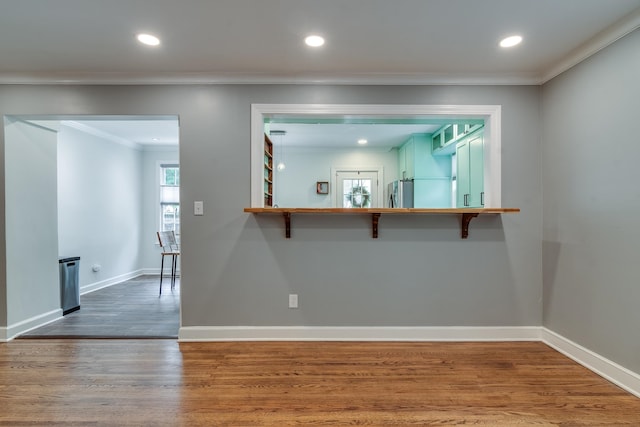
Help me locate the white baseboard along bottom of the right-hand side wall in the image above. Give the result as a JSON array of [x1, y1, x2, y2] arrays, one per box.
[[541, 328, 640, 397]]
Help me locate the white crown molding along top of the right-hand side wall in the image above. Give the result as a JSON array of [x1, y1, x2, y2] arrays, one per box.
[[540, 7, 640, 84]]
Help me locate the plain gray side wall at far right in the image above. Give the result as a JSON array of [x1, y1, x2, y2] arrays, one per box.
[[542, 31, 640, 372]]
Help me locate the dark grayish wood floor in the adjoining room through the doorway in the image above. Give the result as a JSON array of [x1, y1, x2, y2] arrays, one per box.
[[20, 276, 180, 339]]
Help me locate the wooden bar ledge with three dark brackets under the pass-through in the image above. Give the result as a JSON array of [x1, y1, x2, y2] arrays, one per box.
[[244, 207, 520, 239]]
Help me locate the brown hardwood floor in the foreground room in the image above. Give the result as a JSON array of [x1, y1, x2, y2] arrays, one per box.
[[0, 339, 640, 426]]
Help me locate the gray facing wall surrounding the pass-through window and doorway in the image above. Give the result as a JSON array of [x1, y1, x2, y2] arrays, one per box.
[[0, 85, 542, 332]]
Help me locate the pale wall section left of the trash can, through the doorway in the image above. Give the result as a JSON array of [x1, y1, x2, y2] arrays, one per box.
[[4, 119, 60, 326]]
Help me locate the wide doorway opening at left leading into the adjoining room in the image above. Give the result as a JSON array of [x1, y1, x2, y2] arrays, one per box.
[[4, 115, 180, 338]]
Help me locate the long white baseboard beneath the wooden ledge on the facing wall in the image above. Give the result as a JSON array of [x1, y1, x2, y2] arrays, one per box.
[[178, 326, 540, 342]]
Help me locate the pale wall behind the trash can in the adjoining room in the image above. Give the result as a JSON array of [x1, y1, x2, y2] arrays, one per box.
[[58, 126, 143, 290]]
